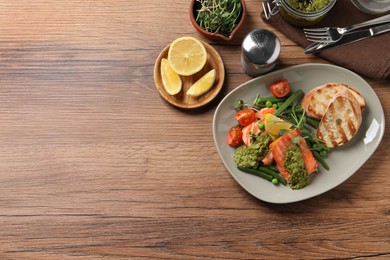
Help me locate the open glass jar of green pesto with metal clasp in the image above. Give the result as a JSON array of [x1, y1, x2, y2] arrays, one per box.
[[263, 0, 336, 27]]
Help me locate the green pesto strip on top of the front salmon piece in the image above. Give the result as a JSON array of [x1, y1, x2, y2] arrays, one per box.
[[284, 144, 310, 190]]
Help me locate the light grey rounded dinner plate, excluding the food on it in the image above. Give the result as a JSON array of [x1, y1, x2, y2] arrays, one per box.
[[213, 64, 385, 203]]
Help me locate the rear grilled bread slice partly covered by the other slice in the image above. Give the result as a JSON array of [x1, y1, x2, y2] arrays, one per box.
[[302, 83, 366, 120]]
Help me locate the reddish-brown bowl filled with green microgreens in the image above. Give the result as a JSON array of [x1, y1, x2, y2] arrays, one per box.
[[190, 0, 246, 41]]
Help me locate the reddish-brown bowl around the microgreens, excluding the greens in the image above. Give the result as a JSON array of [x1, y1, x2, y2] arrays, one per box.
[[189, 0, 246, 41]]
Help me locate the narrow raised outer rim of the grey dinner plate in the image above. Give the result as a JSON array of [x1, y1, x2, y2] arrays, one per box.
[[212, 63, 385, 204]]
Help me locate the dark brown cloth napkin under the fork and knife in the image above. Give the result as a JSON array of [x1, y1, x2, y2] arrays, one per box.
[[261, 0, 390, 80]]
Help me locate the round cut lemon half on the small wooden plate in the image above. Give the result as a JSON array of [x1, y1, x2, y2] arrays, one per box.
[[168, 36, 207, 76]]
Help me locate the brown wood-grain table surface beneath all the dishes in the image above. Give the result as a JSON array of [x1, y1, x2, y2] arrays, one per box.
[[0, 0, 390, 259]]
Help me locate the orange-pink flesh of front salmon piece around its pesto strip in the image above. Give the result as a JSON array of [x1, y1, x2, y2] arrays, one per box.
[[270, 128, 318, 181]]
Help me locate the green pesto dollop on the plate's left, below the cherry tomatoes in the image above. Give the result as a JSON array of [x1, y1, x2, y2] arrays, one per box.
[[233, 133, 272, 169]]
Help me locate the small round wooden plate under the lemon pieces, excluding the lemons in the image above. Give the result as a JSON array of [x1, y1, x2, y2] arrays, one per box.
[[154, 41, 225, 109]]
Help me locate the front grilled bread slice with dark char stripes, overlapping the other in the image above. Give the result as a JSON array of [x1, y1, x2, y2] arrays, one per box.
[[316, 90, 362, 148]]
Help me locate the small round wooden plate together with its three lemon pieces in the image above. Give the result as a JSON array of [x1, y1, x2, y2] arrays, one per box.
[[154, 36, 225, 109]]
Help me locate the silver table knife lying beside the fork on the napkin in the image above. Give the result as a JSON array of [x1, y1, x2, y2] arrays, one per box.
[[305, 23, 390, 54]]
